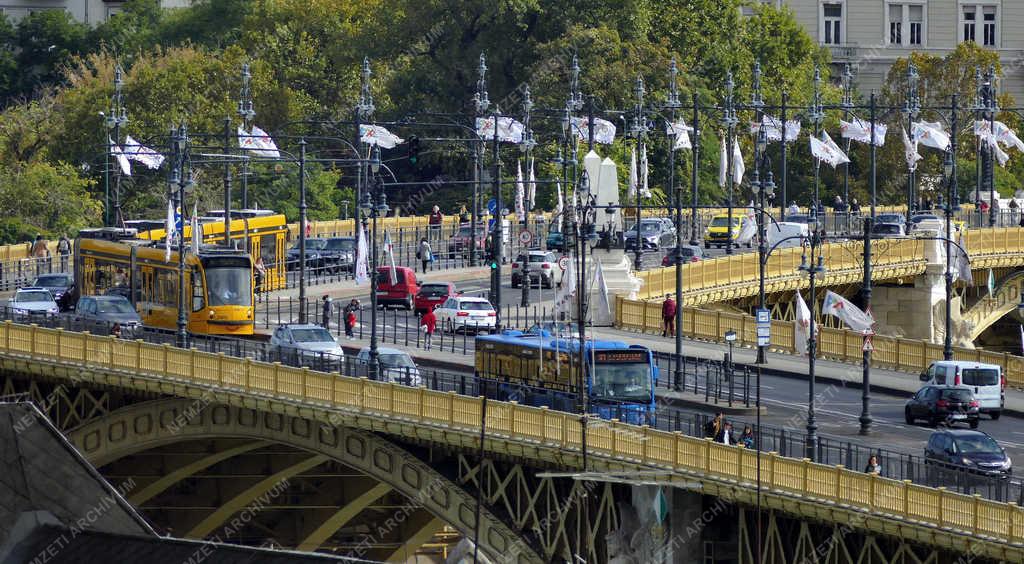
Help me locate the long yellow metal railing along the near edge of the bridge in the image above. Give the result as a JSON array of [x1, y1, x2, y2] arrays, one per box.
[[0, 322, 1024, 545]]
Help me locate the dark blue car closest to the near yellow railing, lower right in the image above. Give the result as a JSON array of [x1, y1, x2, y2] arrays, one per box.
[[925, 429, 1013, 477]]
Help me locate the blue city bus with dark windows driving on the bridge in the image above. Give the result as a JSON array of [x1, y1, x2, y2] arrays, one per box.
[[475, 331, 657, 426]]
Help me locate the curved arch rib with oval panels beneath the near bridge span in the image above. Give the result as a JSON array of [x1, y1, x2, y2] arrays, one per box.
[[69, 398, 543, 564]]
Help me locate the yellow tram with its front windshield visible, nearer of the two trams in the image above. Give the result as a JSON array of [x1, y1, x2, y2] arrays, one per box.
[[75, 228, 255, 336]]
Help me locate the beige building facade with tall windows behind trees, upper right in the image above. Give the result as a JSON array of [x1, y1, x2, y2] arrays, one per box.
[[778, 0, 1024, 103]]
